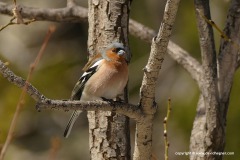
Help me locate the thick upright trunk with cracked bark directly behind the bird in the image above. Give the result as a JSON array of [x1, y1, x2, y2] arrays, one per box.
[[88, 0, 130, 160]]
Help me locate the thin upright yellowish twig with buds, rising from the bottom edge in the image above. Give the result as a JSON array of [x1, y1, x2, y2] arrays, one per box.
[[163, 98, 172, 160]]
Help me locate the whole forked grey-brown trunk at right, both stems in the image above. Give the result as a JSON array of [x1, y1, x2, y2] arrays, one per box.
[[190, 0, 240, 160]]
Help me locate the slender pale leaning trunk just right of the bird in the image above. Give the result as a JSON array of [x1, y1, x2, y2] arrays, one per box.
[[133, 0, 180, 160]]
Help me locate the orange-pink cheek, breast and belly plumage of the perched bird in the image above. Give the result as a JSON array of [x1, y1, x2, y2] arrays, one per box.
[[84, 53, 128, 99]]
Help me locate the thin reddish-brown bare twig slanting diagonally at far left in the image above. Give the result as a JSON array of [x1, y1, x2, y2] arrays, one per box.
[[0, 27, 54, 160]]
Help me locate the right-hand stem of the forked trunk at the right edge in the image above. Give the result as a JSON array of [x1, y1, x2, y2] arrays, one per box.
[[218, 0, 240, 122]]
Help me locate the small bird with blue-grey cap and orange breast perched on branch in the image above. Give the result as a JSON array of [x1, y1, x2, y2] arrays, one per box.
[[64, 42, 128, 138]]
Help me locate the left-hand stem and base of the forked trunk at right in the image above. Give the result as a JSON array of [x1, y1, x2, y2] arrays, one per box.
[[190, 0, 225, 160]]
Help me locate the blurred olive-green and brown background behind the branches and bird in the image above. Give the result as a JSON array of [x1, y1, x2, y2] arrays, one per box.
[[0, 0, 240, 160]]
